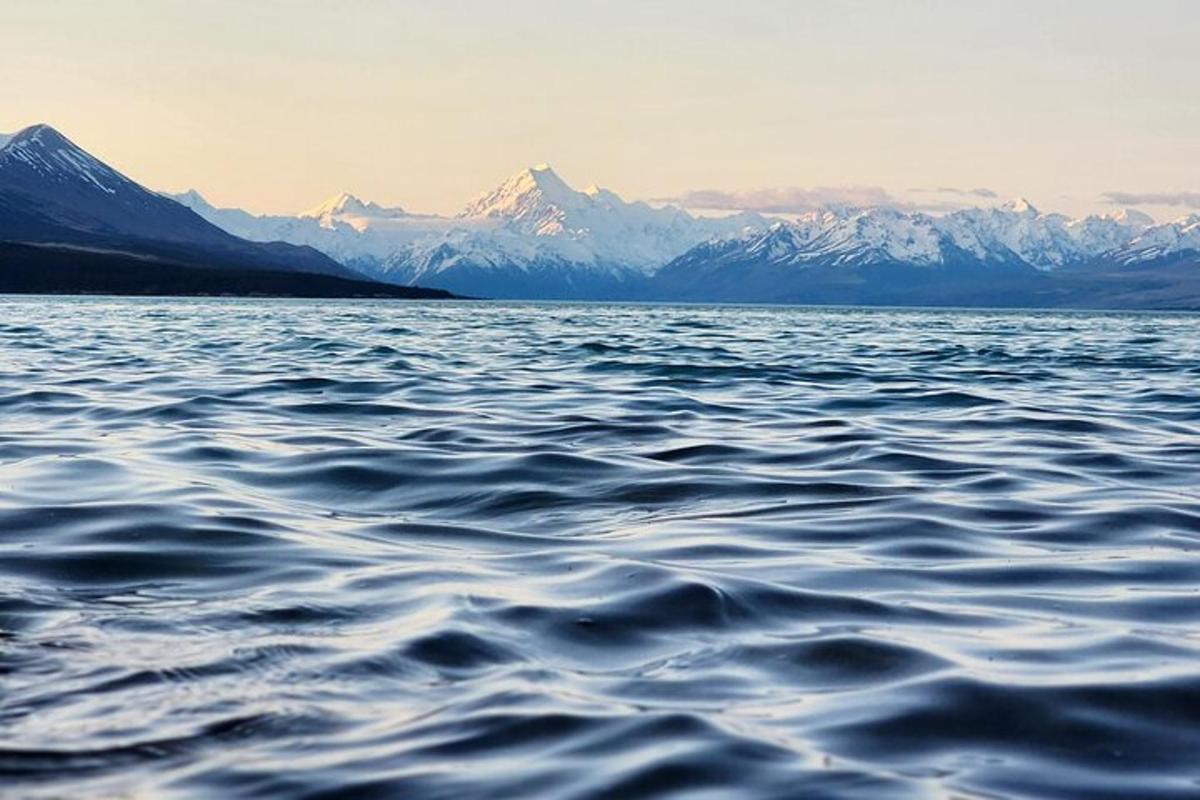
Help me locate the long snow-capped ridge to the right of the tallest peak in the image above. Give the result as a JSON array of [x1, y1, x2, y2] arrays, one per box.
[[649, 200, 1200, 305]]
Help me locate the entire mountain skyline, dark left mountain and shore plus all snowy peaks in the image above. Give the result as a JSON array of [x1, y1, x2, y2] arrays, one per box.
[[0, 125, 1200, 308]]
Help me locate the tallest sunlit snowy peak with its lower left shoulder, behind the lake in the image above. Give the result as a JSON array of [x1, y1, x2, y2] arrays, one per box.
[[170, 164, 767, 297]]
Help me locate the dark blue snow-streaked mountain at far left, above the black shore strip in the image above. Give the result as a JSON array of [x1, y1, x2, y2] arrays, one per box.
[[0, 125, 361, 278]]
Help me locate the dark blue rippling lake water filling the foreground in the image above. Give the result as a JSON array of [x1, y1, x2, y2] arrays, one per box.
[[0, 299, 1200, 799]]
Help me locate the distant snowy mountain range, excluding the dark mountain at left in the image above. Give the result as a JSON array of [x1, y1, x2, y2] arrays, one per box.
[[175, 164, 1200, 306]]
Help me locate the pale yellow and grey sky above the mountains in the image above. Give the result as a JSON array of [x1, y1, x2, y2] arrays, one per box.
[[0, 0, 1200, 219]]
